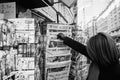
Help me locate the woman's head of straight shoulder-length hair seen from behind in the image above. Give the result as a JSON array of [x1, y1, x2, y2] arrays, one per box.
[[87, 33, 119, 66]]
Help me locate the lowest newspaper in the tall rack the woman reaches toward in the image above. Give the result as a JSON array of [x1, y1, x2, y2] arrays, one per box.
[[46, 61, 71, 80]]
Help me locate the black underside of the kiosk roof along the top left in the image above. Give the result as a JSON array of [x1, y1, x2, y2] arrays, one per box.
[[0, 0, 52, 9]]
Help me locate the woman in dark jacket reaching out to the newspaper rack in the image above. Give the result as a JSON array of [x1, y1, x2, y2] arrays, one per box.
[[57, 33, 120, 80]]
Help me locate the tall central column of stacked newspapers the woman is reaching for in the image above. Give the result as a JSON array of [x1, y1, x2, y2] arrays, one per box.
[[45, 24, 72, 80]]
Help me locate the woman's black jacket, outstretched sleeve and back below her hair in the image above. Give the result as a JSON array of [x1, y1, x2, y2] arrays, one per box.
[[63, 37, 120, 80]]
